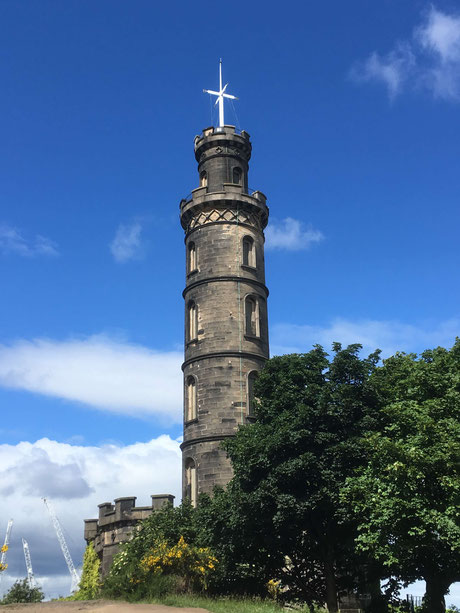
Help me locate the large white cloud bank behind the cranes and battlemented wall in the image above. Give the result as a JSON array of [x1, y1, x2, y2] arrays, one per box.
[[0, 435, 181, 597]]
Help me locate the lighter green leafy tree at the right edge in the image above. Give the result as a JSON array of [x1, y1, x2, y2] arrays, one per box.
[[344, 339, 460, 613]]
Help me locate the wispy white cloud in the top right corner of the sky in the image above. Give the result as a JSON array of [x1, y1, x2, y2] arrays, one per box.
[[350, 7, 460, 101]]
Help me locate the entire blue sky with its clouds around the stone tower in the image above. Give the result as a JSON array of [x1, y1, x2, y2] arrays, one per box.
[[0, 0, 460, 604]]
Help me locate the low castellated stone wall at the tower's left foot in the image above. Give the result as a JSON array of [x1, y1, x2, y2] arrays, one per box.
[[85, 494, 174, 576]]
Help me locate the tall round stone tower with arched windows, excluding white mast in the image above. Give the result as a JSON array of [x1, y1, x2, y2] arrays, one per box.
[[180, 126, 269, 504]]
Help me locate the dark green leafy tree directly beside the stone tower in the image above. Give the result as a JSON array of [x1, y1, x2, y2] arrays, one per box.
[[209, 343, 379, 611]]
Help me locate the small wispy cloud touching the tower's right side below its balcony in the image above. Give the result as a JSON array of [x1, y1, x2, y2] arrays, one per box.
[[265, 217, 324, 251]]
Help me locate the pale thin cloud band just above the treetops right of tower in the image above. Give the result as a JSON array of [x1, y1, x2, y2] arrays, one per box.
[[271, 318, 460, 357]]
